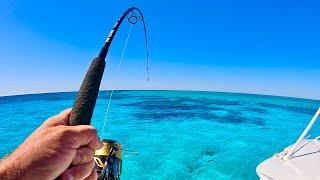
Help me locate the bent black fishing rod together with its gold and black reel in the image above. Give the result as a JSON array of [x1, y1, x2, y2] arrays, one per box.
[[69, 7, 149, 180]]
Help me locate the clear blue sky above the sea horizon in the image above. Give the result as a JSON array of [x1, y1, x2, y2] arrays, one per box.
[[0, 0, 320, 99]]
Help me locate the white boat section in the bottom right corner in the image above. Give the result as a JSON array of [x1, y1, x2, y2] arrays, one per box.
[[256, 140, 320, 180]]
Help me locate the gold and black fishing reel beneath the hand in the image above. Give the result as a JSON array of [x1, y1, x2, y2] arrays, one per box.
[[94, 139, 123, 180]]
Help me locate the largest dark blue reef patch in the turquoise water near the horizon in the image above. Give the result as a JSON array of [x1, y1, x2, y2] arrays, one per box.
[[128, 97, 264, 126]]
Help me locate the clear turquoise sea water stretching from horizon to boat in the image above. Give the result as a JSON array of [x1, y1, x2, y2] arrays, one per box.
[[0, 91, 320, 179]]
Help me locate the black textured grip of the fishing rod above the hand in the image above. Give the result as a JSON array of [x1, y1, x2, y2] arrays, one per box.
[[69, 57, 106, 126]]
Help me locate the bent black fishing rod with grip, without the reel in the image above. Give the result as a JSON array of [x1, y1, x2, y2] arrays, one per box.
[[69, 7, 148, 126]]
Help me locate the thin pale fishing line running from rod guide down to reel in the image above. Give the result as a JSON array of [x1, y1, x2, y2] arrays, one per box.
[[101, 23, 134, 137]]
